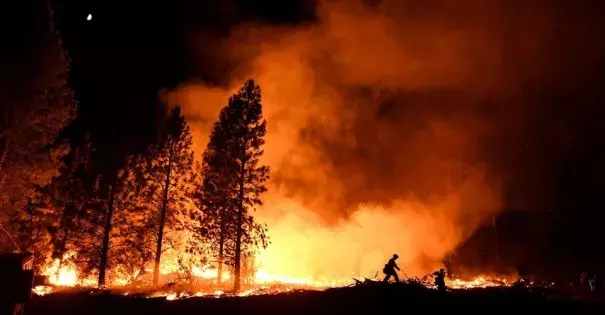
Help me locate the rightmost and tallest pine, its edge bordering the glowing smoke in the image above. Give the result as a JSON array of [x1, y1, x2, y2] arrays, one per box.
[[215, 80, 269, 291]]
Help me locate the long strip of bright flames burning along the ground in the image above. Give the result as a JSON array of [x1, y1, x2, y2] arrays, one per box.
[[32, 244, 520, 300]]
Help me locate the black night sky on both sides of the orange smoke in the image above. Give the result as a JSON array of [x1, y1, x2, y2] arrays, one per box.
[[4, 0, 605, 278]]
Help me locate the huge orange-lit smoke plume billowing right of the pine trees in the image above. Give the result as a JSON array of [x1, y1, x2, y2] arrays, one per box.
[[167, 0, 580, 277]]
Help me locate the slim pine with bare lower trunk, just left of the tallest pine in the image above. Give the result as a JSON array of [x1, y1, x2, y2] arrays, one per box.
[[143, 106, 195, 285]]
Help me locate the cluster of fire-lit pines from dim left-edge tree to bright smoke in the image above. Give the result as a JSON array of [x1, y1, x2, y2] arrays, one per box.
[[12, 70, 269, 290]]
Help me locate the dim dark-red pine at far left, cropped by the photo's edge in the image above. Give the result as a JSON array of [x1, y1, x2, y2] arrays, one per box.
[[0, 0, 77, 243]]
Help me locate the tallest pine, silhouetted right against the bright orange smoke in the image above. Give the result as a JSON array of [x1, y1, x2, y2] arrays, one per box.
[[202, 80, 269, 291]]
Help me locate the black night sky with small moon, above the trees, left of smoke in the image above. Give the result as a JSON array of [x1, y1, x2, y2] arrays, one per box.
[[47, 0, 313, 152]]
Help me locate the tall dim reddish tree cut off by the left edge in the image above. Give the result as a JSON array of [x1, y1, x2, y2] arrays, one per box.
[[0, 2, 77, 251]]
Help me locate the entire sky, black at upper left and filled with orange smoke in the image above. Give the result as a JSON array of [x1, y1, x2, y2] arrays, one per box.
[[34, 0, 605, 275]]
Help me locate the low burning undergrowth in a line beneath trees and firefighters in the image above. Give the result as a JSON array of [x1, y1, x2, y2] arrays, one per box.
[[32, 267, 528, 301]]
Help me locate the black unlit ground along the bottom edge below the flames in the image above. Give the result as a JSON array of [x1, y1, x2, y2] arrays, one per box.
[[26, 285, 605, 315]]
